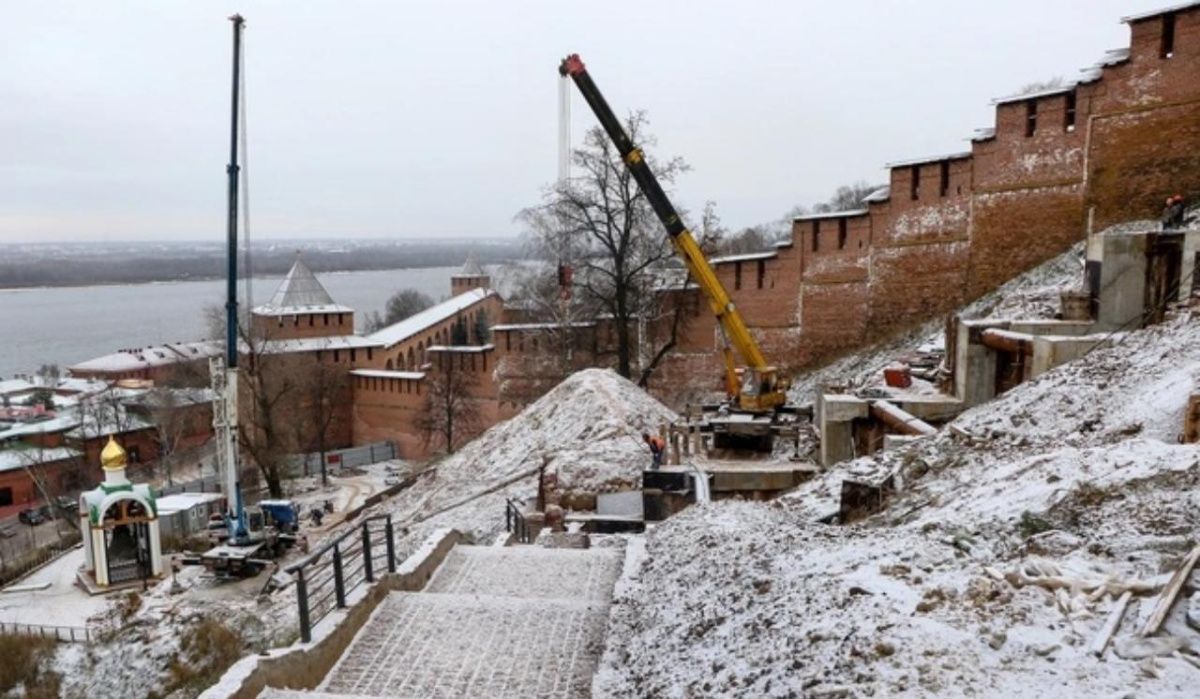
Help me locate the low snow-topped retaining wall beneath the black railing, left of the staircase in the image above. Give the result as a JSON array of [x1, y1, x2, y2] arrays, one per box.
[[200, 530, 462, 699]]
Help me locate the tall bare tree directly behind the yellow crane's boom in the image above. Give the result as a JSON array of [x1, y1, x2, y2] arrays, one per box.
[[518, 112, 686, 378]]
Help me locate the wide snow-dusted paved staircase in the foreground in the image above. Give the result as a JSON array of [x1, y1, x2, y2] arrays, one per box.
[[260, 546, 622, 699]]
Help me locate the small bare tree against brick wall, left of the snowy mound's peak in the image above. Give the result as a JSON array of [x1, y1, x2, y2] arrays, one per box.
[[416, 352, 480, 454]]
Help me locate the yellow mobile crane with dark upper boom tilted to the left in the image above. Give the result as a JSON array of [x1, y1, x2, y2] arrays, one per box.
[[558, 54, 796, 452]]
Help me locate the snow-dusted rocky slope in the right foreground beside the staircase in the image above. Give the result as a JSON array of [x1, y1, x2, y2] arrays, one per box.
[[595, 311, 1200, 697]]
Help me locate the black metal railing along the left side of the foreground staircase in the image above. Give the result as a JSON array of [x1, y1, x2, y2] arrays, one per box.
[[287, 514, 396, 643]]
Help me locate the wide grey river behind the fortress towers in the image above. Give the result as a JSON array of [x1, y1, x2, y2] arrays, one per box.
[[0, 267, 458, 378]]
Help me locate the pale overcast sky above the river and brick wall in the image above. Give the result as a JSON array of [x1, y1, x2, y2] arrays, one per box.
[[0, 0, 1170, 241]]
